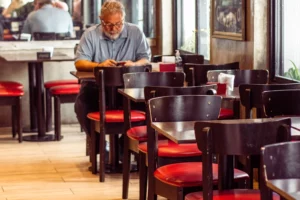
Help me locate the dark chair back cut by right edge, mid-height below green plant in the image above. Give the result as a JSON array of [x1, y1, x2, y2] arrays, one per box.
[[262, 89, 300, 117]]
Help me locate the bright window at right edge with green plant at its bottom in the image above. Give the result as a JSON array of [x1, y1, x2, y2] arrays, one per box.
[[270, 0, 300, 81]]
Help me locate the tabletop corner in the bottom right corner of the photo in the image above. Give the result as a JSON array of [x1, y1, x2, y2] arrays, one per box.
[[267, 179, 300, 200]]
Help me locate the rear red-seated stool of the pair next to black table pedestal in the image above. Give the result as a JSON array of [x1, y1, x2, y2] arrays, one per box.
[[44, 79, 78, 132]]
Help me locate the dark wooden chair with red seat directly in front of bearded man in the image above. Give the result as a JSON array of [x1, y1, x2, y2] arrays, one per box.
[[87, 65, 151, 182]]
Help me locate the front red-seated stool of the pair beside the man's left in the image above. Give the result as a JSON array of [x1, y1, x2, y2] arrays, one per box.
[[49, 83, 80, 141]]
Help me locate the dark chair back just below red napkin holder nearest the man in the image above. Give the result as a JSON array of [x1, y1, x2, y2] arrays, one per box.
[[123, 72, 185, 88]]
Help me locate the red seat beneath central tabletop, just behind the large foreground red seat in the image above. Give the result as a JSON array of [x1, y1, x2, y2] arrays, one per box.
[[139, 140, 202, 157]]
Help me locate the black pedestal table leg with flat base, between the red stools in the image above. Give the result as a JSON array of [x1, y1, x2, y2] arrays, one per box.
[[23, 62, 55, 142]]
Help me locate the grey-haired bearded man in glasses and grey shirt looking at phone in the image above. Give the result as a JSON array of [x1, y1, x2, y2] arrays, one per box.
[[75, 0, 151, 138]]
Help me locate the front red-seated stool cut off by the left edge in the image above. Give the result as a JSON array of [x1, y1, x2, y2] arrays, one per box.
[[0, 87, 24, 143]]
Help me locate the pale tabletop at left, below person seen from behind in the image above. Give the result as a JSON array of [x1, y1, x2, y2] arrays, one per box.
[[0, 50, 74, 62]]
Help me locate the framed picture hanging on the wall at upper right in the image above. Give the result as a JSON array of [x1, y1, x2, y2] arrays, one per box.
[[211, 0, 246, 40]]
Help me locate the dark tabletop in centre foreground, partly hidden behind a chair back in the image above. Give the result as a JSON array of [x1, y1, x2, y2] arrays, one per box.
[[151, 117, 300, 144]]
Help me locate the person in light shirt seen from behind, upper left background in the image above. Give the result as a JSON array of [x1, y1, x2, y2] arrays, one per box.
[[22, 0, 73, 35]]
